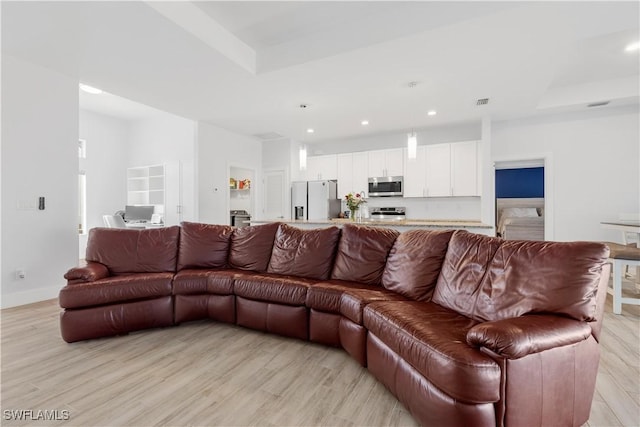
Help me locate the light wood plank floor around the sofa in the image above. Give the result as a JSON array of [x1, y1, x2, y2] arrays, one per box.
[[1, 286, 640, 427]]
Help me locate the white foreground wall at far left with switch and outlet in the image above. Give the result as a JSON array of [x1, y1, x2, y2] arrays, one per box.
[[1, 55, 78, 307]]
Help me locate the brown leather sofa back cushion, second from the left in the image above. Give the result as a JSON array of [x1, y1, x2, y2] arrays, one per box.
[[178, 222, 233, 270]]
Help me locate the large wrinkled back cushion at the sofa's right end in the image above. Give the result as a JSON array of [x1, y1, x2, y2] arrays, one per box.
[[433, 233, 609, 321]]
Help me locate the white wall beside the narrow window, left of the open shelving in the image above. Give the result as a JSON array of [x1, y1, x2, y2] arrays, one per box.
[[79, 110, 130, 258]]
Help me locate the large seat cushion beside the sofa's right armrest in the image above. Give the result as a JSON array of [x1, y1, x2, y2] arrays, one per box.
[[364, 301, 501, 403]]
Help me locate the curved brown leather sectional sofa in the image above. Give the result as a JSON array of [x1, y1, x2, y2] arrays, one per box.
[[60, 223, 609, 426]]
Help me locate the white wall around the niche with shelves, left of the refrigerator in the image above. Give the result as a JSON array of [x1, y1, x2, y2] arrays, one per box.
[[197, 122, 263, 224]]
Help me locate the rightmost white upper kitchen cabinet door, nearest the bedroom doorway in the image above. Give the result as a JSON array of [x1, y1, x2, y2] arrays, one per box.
[[451, 141, 480, 196]]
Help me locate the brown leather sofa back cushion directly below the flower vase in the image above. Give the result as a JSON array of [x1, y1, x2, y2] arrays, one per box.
[[331, 224, 400, 285]]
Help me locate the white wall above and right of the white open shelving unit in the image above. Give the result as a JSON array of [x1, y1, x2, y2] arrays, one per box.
[[128, 113, 197, 225]]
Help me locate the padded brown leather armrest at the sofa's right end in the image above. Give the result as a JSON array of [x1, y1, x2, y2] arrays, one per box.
[[467, 315, 591, 359]]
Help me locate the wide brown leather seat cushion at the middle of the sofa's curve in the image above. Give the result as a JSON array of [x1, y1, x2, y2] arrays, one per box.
[[233, 273, 316, 305]]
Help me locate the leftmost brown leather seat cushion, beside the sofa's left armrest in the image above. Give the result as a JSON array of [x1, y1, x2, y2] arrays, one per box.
[[59, 273, 173, 308]]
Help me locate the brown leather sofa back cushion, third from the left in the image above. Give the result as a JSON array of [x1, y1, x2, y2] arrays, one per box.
[[229, 222, 280, 272]]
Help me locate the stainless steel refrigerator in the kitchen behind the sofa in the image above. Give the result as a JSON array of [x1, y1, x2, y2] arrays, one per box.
[[291, 180, 340, 221]]
